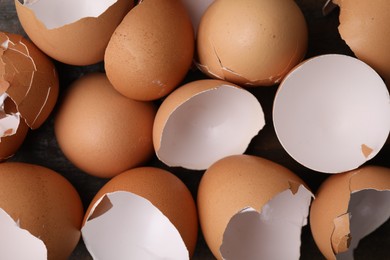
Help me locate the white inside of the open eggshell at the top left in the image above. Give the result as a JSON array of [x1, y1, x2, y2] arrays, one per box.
[[24, 0, 117, 29]]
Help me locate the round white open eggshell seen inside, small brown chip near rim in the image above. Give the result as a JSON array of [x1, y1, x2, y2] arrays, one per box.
[[273, 54, 390, 173]]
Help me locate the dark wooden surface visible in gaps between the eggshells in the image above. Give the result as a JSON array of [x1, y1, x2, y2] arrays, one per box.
[[0, 0, 390, 259]]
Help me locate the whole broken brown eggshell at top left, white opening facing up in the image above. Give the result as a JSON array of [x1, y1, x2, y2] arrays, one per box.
[[15, 0, 134, 65]]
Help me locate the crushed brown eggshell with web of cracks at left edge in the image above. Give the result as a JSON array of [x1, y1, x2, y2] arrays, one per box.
[[0, 32, 59, 160]]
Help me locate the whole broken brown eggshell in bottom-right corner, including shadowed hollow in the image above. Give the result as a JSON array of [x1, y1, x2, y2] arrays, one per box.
[[310, 165, 390, 259]]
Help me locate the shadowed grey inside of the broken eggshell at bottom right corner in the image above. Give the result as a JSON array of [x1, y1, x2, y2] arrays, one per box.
[[337, 189, 390, 260]]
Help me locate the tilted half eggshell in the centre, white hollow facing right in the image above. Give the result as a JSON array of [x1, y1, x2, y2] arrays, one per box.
[[153, 79, 265, 170]]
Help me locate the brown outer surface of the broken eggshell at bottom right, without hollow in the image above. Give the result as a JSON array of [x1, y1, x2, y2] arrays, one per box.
[[310, 166, 390, 259]]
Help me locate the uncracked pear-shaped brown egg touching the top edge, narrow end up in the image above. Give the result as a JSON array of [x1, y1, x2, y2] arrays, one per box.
[[104, 0, 194, 100]]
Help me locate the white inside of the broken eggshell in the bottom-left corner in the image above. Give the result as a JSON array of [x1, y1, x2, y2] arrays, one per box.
[[0, 208, 47, 259]]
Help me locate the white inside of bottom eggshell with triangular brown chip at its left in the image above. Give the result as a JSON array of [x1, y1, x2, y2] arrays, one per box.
[[81, 191, 189, 259]]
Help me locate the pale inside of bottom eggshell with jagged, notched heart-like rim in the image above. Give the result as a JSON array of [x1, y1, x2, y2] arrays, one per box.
[[220, 185, 313, 260]]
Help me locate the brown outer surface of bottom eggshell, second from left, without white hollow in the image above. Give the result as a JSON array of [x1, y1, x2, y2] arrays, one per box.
[[82, 167, 198, 257]]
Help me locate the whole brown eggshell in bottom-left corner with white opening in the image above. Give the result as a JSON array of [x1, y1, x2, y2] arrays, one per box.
[[0, 162, 84, 260]]
